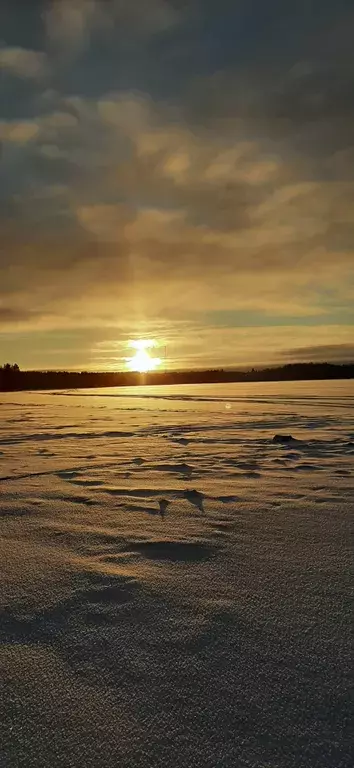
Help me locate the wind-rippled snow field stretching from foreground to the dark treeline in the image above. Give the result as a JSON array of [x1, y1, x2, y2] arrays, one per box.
[[0, 382, 354, 768]]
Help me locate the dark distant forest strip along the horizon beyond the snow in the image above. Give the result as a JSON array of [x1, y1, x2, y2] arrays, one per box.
[[0, 363, 354, 392]]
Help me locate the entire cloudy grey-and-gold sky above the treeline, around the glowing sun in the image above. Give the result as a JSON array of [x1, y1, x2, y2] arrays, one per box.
[[0, 0, 354, 370]]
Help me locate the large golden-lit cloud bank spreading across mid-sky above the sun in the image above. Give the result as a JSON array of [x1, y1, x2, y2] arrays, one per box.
[[2, 93, 354, 330]]
